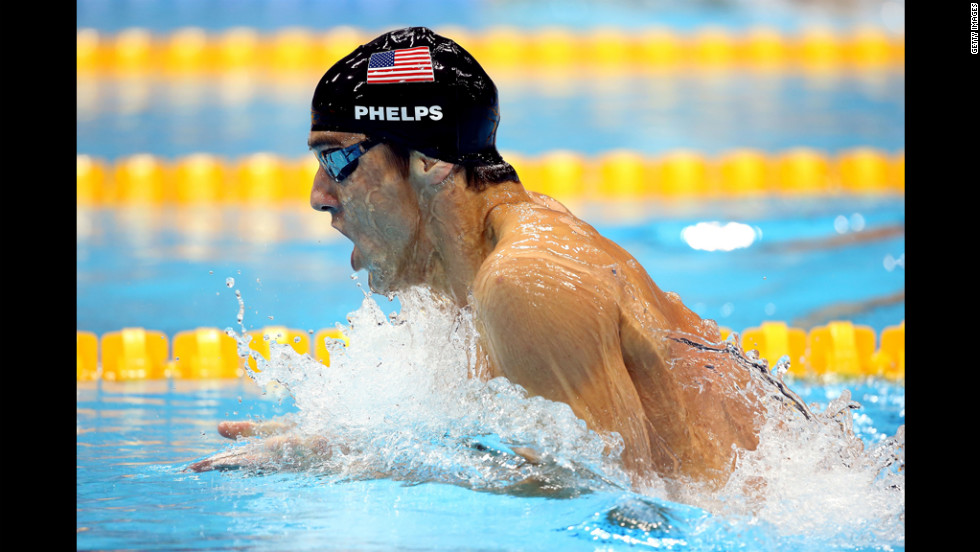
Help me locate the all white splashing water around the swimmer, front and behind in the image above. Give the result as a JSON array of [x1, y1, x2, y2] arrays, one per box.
[[216, 283, 905, 549]]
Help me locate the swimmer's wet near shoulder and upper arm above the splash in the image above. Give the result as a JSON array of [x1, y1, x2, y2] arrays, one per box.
[[474, 255, 645, 446]]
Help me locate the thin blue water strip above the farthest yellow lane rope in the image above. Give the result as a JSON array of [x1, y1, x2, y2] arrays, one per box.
[[77, 0, 905, 31]]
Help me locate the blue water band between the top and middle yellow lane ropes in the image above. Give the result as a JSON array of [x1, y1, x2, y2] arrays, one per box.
[[76, 72, 905, 160]]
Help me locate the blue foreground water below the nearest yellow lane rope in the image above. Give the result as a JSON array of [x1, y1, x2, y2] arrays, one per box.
[[77, 374, 905, 551]]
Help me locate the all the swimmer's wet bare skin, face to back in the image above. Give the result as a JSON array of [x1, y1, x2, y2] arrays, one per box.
[[191, 132, 763, 484]]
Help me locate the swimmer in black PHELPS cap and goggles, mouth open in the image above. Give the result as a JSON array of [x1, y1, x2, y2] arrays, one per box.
[[190, 28, 764, 485]]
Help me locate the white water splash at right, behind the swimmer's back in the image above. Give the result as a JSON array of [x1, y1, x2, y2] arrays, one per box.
[[687, 339, 905, 549]]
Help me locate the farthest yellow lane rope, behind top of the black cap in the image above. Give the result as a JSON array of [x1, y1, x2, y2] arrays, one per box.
[[76, 26, 905, 78]]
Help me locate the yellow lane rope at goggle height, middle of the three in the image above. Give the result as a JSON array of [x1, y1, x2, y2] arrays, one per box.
[[76, 147, 905, 206]]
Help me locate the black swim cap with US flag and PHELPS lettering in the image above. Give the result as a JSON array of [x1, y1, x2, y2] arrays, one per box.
[[310, 27, 503, 166]]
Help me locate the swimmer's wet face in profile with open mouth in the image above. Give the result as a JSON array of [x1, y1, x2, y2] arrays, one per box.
[[309, 131, 419, 293]]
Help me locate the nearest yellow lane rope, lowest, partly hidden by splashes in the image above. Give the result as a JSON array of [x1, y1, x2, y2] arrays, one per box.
[[76, 320, 905, 382]]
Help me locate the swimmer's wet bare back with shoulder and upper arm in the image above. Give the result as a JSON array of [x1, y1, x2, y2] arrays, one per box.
[[474, 196, 757, 479]]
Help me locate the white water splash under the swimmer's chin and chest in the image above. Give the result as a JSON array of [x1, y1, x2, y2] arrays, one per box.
[[228, 288, 629, 496]]
